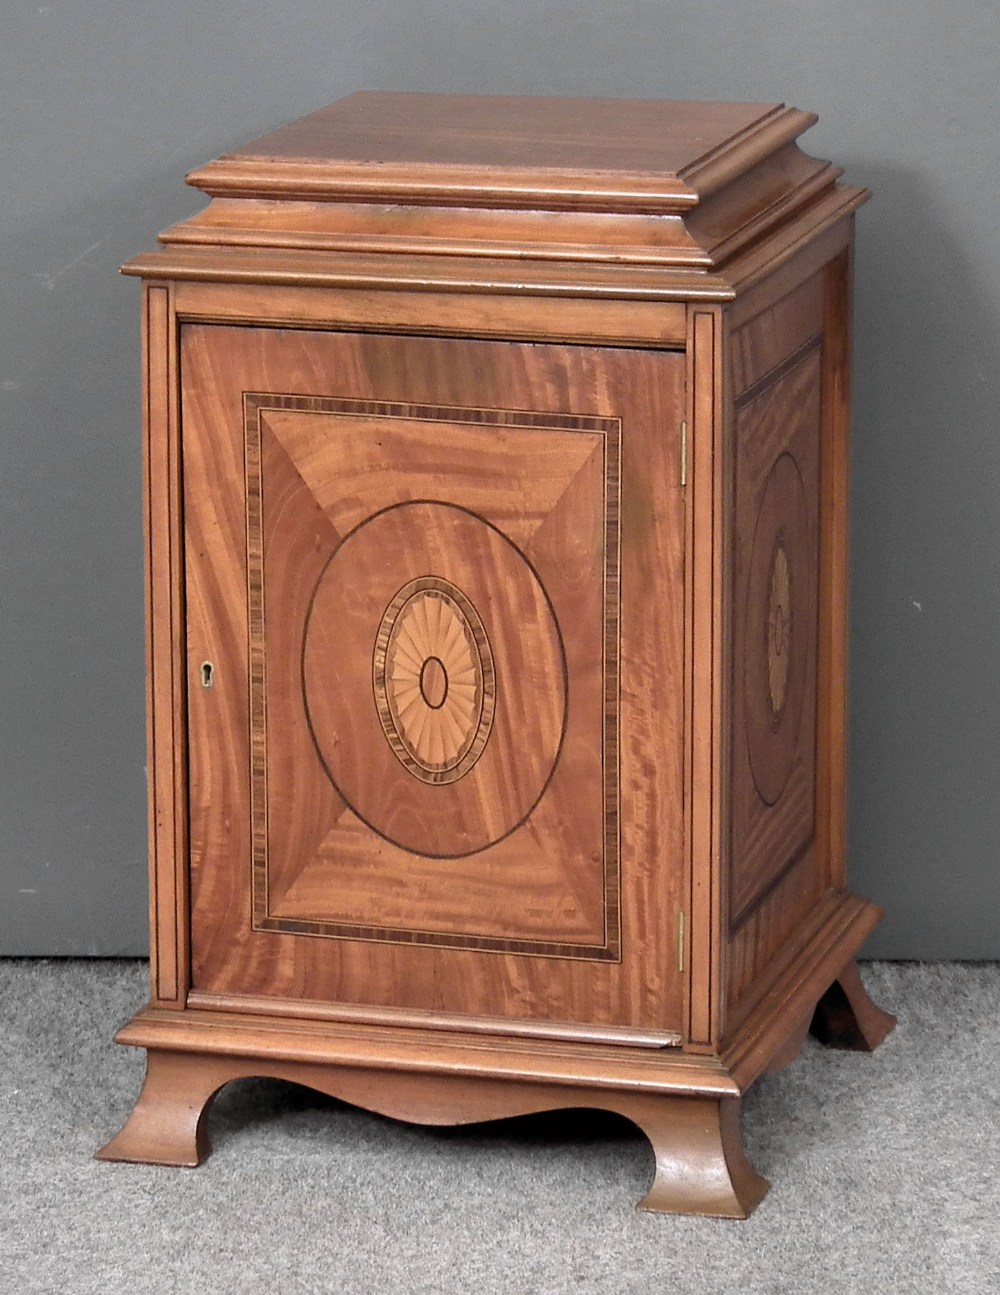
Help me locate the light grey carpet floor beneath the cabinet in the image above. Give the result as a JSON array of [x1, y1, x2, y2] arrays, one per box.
[[0, 961, 1000, 1295]]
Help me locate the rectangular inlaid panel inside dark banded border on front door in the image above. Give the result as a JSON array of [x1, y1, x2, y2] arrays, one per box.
[[225, 365, 632, 961]]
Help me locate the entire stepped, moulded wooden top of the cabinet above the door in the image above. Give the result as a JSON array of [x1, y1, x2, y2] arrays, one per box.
[[124, 93, 867, 300]]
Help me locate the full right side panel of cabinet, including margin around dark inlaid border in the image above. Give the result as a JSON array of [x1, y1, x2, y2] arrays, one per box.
[[723, 271, 843, 1030]]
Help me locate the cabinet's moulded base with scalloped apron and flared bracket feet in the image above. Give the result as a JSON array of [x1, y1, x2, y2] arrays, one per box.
[[97, 922, 895, 1219]]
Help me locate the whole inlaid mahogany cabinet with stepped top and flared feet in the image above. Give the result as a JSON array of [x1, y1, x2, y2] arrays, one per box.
[[101, 95, 891, 1216]]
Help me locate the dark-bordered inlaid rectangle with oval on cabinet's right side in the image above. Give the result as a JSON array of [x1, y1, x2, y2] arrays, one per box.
[[728, 342, 820, 935]]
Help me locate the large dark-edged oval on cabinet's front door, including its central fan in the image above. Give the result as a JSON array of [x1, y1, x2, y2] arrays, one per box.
[[301, 501, 567, 859]]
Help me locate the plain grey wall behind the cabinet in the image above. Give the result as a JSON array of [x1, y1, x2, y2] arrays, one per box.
[[0, 0, 1000, 958]]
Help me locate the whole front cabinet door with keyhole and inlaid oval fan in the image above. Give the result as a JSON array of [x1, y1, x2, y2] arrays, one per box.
[[181, 325, 684, 1030]]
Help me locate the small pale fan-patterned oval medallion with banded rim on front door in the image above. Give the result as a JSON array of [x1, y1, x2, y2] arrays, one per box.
[[372, 576, 496, 783]]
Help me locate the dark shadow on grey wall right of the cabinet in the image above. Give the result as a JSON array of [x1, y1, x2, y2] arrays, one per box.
[[850, 166, 1000, 958]]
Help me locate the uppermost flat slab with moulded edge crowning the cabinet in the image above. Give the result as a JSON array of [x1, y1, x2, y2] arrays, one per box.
[[188, 92, 816, 211]]
